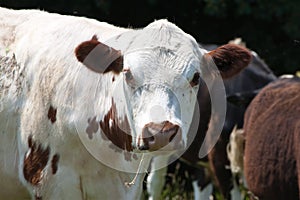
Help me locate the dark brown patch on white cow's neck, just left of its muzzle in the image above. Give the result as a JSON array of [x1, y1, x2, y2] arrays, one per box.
[[100, 99, 132, 151]]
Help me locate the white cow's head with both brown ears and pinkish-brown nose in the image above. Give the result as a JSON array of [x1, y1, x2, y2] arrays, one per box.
[[75, 20, 251, 151]]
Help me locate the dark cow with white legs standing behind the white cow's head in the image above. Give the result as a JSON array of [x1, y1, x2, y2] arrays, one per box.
[[147, 44, 277, 199]]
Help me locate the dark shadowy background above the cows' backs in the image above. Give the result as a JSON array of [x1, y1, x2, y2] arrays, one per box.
[[0, 0, 300, 75]]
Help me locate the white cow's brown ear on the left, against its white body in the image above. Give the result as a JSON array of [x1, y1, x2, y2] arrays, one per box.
[[75, 36, 123, 74]]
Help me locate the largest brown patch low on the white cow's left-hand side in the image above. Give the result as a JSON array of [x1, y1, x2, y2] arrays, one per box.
[[23, 136, 50, 185]]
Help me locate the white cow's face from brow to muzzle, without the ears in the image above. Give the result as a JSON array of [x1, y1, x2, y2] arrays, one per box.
[[123, 47, 200, 151]]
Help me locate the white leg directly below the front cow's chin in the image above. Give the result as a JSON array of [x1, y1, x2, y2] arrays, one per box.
[[147, 156, 169, 200]]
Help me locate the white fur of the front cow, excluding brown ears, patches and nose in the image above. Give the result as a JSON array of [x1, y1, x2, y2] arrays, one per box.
[[0, 8, 209, 199]]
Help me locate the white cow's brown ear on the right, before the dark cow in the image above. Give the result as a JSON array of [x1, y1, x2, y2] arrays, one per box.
[[204, 44, 252, 79]]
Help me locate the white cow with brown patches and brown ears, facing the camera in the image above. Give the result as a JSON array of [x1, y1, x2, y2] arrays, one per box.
[[0, 8, 251, 199]]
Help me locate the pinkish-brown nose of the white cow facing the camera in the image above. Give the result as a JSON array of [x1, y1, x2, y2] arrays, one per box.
[[139, 121, 179, 151]]
